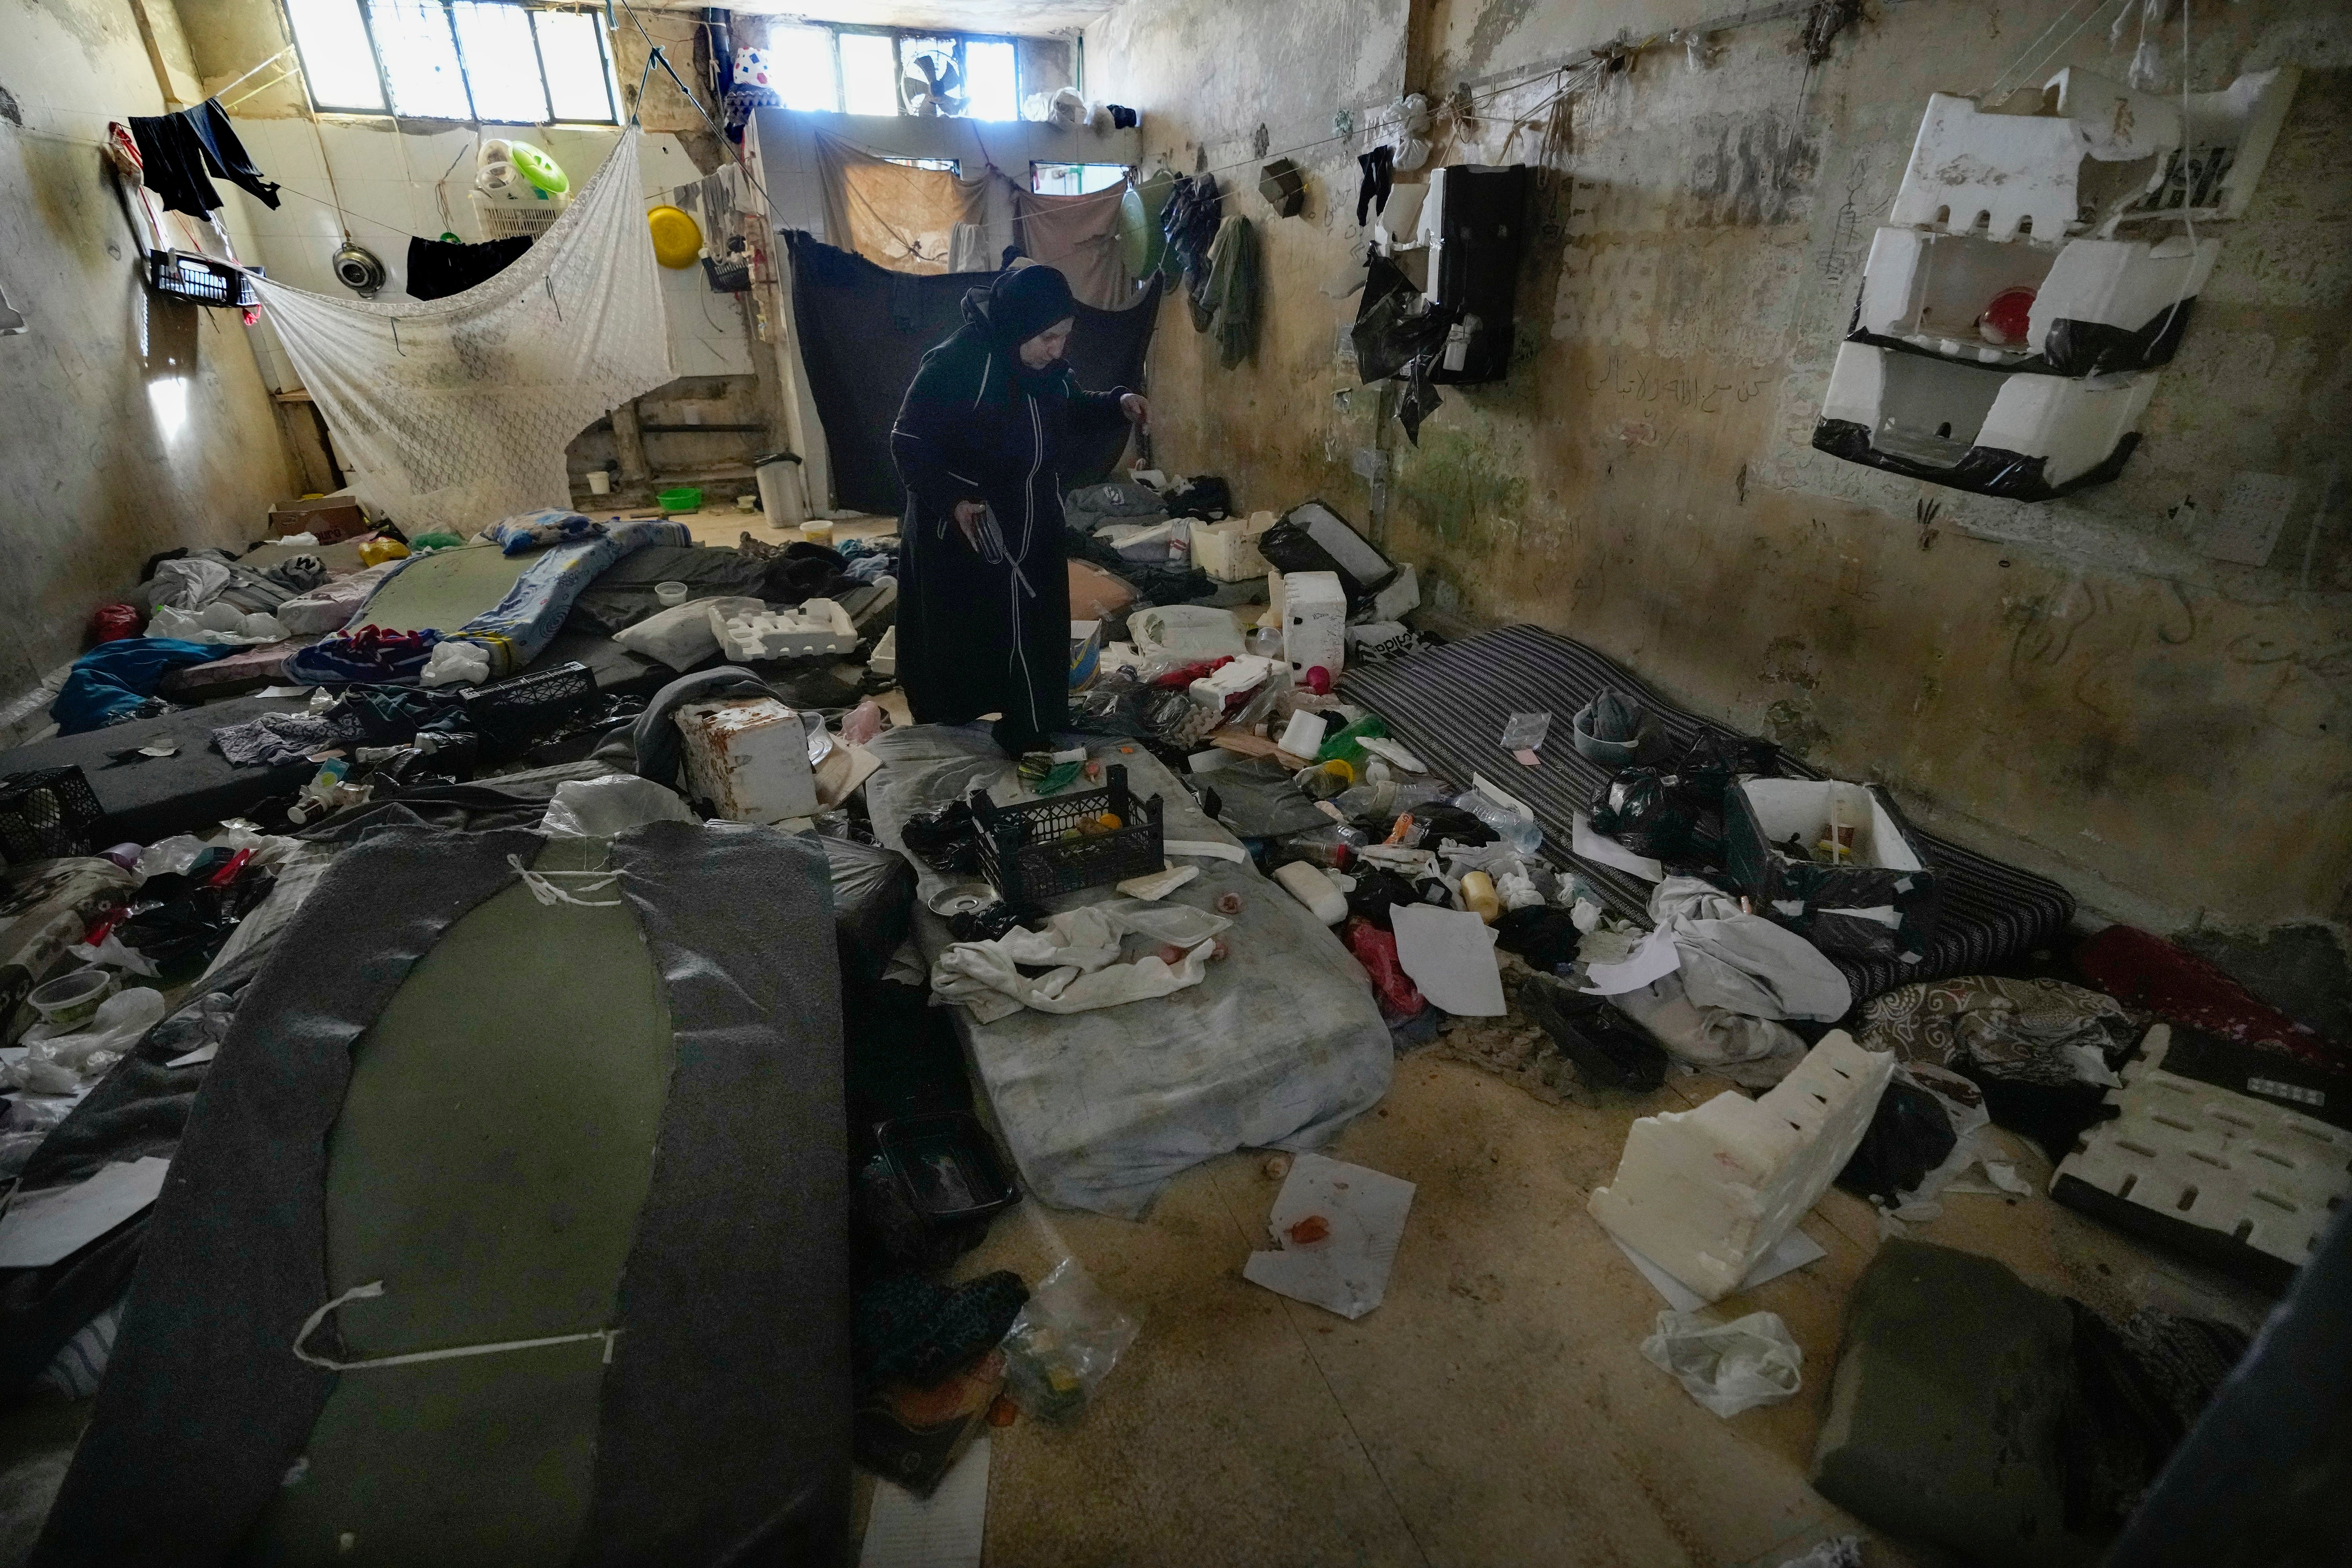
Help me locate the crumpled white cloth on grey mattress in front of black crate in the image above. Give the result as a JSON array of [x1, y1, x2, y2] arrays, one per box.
[[931, 898, 1232, 1023]]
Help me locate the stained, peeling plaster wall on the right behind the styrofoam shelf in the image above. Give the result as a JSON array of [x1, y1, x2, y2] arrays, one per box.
[[1087, 0, 2352, 926]]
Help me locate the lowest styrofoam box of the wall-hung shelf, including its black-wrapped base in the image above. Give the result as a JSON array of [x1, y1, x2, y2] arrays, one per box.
[[1813, 343, 2157, 501]]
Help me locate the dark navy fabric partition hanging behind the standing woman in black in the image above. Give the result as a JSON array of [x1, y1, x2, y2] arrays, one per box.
[[786, 230, 1160, 517]]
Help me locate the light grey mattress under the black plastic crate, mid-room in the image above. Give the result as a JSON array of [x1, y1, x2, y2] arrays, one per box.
[[866, 724, 1395, 1218]]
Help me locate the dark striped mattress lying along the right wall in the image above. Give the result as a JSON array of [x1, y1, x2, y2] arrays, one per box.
[[1338, 625, 2074, 1002]]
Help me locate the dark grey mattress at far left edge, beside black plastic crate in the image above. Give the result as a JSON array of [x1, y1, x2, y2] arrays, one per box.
[[0, 696, 318, 849]]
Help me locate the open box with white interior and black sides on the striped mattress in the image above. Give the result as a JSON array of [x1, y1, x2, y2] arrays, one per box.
[[1724, 778, 1943, 957]]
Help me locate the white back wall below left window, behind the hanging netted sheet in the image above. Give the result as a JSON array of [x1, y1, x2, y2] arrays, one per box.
[[235, 115, 753, 388]]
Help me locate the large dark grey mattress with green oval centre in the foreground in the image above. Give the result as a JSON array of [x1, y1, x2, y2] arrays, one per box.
[[33, 823, 849, 1566]]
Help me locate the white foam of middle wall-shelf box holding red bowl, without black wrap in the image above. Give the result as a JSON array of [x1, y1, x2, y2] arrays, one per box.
[[1858, 228, 2220, 365]]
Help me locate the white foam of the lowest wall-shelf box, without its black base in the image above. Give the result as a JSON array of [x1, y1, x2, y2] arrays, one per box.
[[1820, 343, 2157, 484]]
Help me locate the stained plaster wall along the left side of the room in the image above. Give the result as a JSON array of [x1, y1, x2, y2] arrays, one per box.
[[0, 0, 296, 698]]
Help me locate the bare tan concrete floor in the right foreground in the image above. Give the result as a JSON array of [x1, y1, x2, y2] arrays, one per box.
[[908, 1051, 2260, 1568]]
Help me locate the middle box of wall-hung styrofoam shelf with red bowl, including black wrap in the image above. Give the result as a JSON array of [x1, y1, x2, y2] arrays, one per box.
[[1853, 226, 2220, 376]]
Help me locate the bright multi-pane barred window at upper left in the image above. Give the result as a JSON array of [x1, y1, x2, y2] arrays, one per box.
[[285, 0, 619, 125]]
